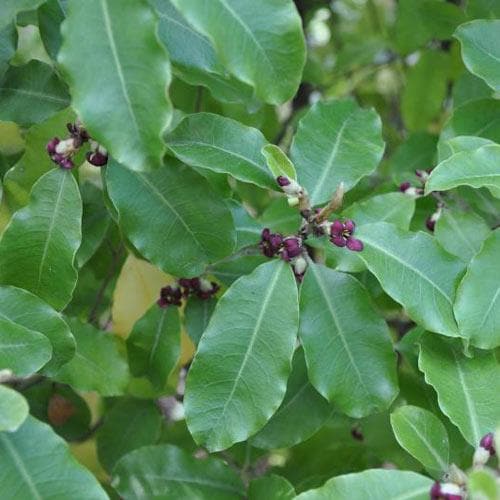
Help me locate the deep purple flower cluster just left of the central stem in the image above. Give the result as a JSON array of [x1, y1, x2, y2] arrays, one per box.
[[259, 227, 307, 281]]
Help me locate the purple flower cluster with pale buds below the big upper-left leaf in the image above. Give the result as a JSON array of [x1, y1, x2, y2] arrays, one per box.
[[46, 122, 108, 169]]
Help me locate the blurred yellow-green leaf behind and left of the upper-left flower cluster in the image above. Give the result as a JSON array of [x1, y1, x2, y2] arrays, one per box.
[[4, 109, 75, 209]]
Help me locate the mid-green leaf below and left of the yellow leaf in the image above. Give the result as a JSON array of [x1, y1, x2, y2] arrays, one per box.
[[54, 318, 129, 396]]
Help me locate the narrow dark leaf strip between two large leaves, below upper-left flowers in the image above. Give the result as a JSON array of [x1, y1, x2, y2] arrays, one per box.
[[76, 182, 111, 268]]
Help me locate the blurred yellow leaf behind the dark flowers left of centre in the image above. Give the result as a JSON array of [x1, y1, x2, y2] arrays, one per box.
[[112, 254, 173, 337]]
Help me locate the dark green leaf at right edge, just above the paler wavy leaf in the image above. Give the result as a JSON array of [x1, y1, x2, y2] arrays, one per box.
[[439, 99, 500, 143]]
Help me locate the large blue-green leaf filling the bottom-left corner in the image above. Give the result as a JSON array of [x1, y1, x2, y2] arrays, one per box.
[[0, 417, 108, 500]]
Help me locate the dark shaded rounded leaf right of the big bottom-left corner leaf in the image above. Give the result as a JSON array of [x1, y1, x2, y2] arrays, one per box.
[[96, 399, 162, 472]]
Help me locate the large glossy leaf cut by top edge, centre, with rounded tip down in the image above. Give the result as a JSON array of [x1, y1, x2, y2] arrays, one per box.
[[172, 0, 306, 104]]
